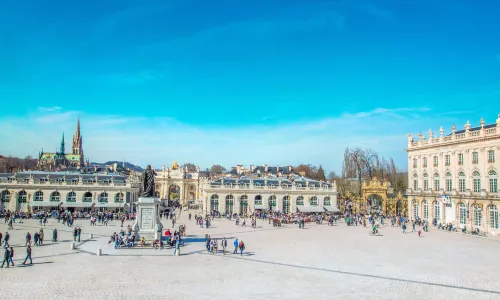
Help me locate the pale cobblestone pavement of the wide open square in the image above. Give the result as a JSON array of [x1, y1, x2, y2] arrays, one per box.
[[0, 212, 500, 299]]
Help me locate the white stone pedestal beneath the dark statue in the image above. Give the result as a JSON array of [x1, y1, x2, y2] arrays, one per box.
[[132, 197, 163, 241]]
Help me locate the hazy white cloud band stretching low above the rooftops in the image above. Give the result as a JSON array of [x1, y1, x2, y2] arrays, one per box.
[[0, 108, 462, 172]]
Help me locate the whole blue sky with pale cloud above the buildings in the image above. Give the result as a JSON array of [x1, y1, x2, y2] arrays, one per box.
[[0, 0, 500, 172]]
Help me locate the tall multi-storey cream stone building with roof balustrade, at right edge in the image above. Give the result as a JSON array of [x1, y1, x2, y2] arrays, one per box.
[[407, 114, 500, 232]]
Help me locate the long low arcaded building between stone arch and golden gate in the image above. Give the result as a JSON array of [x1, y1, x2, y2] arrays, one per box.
[[200, 177, 338, 215]]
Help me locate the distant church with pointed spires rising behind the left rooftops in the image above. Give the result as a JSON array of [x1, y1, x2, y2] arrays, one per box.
[[38, 118, 85, 171]]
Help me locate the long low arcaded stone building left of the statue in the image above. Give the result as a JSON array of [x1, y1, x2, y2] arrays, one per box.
[[0, 171, 139, 212]]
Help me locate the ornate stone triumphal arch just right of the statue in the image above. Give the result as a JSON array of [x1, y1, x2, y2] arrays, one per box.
[[155, 161, 200, 205]]
